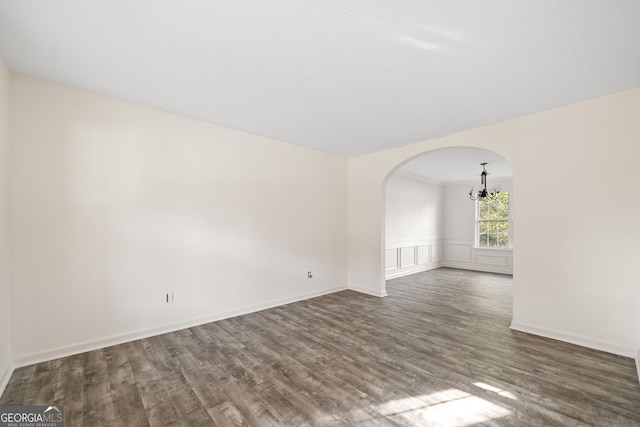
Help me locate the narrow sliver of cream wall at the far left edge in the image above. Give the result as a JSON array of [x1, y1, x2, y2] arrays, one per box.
[[0, 56, 13, 394]]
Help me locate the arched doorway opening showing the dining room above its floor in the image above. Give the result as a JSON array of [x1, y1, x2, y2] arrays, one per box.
[[382, 147, 515, 293]]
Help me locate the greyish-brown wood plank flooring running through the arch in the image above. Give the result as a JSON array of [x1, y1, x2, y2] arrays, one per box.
[[0, 268, 640, 427]]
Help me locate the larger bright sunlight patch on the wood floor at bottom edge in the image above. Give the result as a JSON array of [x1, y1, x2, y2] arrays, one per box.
[[378, 388, 511, 427]]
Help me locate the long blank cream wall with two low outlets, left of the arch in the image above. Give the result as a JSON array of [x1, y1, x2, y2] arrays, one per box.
[[11, 75, 348, 365]]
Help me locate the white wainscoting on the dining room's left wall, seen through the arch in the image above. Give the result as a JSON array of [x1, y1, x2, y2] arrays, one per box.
[[385, 240, 443, 279]]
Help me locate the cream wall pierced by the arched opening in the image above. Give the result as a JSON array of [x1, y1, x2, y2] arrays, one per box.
[[349, 89, 640, 357]]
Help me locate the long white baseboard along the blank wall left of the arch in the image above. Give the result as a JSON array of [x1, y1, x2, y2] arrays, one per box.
[[12, 286, 347, 368]]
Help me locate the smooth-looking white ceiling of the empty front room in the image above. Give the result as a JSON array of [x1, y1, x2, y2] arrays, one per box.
[[0, 0, 640, 157]]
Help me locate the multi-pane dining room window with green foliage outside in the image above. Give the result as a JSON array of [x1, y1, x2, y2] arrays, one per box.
[[476, 192, 511, 249]]
